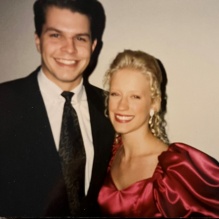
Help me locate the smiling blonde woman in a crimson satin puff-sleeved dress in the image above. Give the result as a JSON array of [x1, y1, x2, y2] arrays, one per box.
[[98, 50, 219, 217]]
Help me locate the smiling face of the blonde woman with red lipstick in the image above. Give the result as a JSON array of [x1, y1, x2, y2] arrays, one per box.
[[109, 68, 153, 134]]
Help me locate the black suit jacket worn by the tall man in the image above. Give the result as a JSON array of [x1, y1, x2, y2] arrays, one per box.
[[0, 69, 114, 217]]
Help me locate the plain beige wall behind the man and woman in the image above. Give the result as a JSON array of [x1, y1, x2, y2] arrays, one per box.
[[0, 0, 219, 160]]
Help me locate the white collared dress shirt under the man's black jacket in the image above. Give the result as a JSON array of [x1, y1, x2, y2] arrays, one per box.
[[38, 70, 94, 194]]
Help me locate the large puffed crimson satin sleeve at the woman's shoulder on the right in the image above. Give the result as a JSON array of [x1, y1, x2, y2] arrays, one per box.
[[154, 143, 219, 218]]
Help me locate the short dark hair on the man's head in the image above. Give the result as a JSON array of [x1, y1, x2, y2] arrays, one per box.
[[33, 0, 106, 41]]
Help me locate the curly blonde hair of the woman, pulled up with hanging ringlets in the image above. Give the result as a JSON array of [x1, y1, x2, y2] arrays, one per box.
[[103, 50, 169, 144]]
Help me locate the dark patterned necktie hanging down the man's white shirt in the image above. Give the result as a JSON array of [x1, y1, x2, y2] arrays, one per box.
[[59, 91, 86, 216]]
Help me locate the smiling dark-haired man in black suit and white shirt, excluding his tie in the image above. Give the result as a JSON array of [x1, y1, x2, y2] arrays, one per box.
[[0, 0, 114, 217]]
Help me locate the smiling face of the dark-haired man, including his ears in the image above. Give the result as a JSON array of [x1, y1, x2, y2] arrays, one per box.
[[35, 7, 96, 90]]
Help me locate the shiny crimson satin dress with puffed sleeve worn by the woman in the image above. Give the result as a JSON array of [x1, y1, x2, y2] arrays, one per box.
[[98, 139, 219, 218]]
